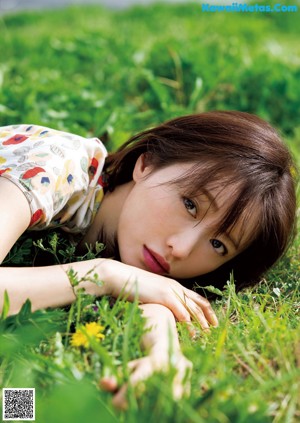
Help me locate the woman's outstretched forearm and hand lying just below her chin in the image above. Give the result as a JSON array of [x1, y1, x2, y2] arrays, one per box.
[[0, 259, 217, 329]]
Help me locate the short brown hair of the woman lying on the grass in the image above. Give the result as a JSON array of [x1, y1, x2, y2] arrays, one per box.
[[106, 111, 296, 289]]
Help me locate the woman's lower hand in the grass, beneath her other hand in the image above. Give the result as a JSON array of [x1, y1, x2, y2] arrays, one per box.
[[100, 304, 192, 409]]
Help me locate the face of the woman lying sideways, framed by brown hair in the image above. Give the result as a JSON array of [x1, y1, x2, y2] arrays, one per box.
[[117, 156, 254, 279]]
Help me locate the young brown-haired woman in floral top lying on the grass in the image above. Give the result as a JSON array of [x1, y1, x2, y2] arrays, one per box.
[[0, 112, 296, 405]]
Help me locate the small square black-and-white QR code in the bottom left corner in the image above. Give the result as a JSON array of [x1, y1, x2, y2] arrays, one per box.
[[2, 388, 35, 420]]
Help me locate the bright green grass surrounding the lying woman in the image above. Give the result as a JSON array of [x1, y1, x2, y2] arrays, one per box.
[[0, 4, 300, 423]]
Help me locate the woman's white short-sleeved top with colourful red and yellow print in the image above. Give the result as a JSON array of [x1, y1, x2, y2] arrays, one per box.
[[0, 125, 107, 232]]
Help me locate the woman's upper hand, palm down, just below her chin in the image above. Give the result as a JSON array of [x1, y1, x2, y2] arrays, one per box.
[[99, 260, 218, 330]]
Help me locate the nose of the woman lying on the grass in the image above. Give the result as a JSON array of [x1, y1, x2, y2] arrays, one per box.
[[167, 230, 199, 260]]
